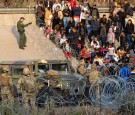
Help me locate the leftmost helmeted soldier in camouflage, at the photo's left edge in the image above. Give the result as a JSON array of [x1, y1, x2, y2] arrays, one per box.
[[0, 67, 13, 103]]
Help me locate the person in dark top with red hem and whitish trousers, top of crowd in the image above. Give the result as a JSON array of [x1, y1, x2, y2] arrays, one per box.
[[72, 1, 81, 26]]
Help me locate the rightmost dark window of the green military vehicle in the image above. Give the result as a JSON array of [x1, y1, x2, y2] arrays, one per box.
[[52, 63, 69, 71]]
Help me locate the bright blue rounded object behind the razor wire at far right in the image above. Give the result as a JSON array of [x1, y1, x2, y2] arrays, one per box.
[[119, 66, 131, 79]]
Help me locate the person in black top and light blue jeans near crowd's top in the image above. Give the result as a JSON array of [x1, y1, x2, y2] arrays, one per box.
[[63, 5, 71, 29]]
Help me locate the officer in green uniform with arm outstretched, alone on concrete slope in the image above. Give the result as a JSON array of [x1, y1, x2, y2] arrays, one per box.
[[17, 17, 32, 49]]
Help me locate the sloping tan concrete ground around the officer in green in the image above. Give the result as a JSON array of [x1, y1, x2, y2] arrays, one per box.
[[0, 16, 65, 61]]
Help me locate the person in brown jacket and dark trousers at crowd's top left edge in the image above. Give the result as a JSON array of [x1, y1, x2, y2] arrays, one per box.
[[37, 2, 45, 30]]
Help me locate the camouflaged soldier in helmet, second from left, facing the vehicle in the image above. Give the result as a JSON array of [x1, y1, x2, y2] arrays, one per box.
[[17, 68, 36, 109]]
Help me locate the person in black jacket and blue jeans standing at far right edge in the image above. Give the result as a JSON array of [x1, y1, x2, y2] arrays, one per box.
[[125, 19, 134, 48]]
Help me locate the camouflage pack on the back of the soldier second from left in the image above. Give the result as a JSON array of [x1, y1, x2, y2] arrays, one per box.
[[23, 78, 36, 93]]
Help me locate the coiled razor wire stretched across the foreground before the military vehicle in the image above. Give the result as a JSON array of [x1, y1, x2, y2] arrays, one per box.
[[0, 73, 135, 115]]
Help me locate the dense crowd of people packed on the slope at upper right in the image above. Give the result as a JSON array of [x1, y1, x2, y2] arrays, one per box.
[[36, 0, 135, 65]]
